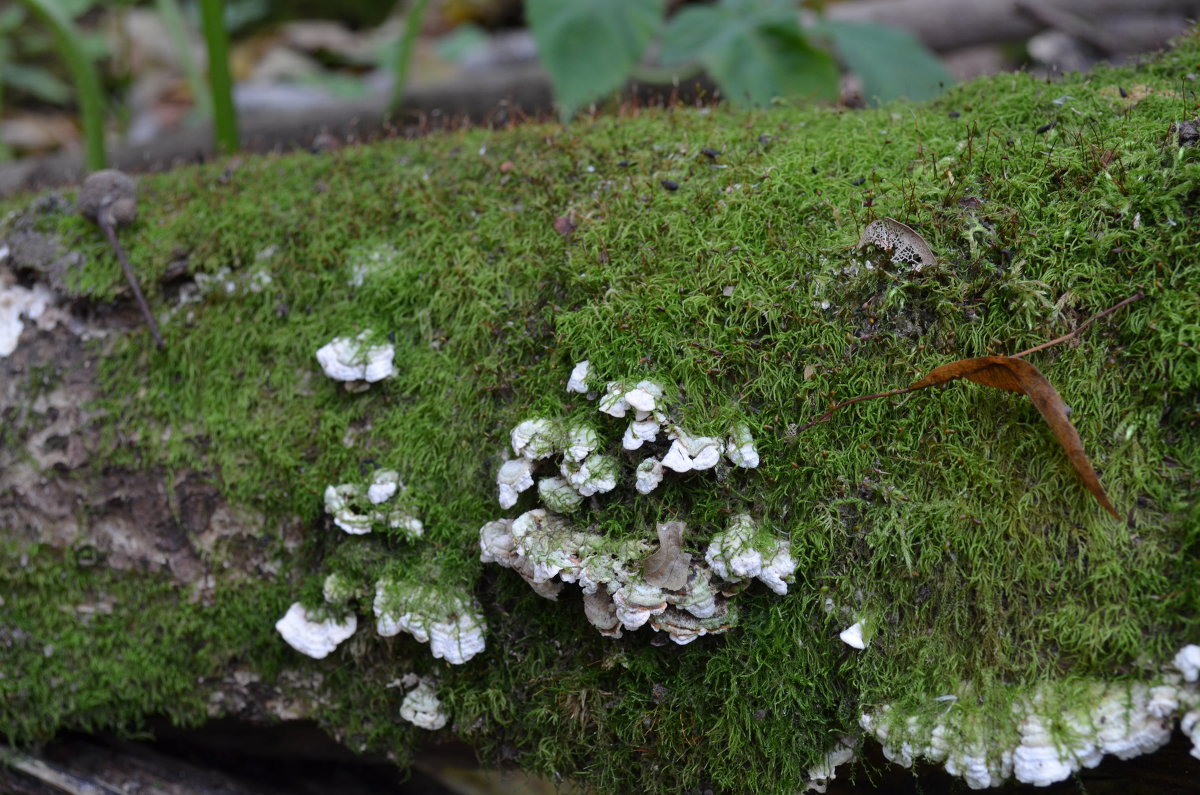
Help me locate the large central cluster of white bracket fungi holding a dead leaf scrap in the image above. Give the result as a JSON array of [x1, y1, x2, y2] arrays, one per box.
[[480, 361, 796, 644]]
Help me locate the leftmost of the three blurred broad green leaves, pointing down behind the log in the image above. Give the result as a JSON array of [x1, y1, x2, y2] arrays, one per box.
[[526, 0, 665, 119]]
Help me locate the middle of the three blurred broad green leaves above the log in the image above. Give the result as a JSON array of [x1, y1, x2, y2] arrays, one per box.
[[661, 0, 838, 106]]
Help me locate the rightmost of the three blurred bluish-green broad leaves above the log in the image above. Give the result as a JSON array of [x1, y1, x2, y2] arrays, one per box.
[[814, 22, 954, 104]]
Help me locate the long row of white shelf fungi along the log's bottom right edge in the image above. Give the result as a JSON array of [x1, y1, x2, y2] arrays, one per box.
[[860, 645, 1200, 789]]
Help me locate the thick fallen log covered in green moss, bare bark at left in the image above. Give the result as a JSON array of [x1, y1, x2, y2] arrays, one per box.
[[0, 28, 1200, 793]]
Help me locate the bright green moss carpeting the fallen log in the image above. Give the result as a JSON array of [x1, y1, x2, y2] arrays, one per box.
[[4, 31, 1200, 793]]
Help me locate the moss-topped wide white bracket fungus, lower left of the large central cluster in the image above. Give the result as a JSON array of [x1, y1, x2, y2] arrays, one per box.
[[373, 579, 487, 665]]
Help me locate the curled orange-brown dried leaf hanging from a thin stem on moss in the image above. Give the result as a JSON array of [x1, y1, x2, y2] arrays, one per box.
[[910, 357, 1121, 519]]
